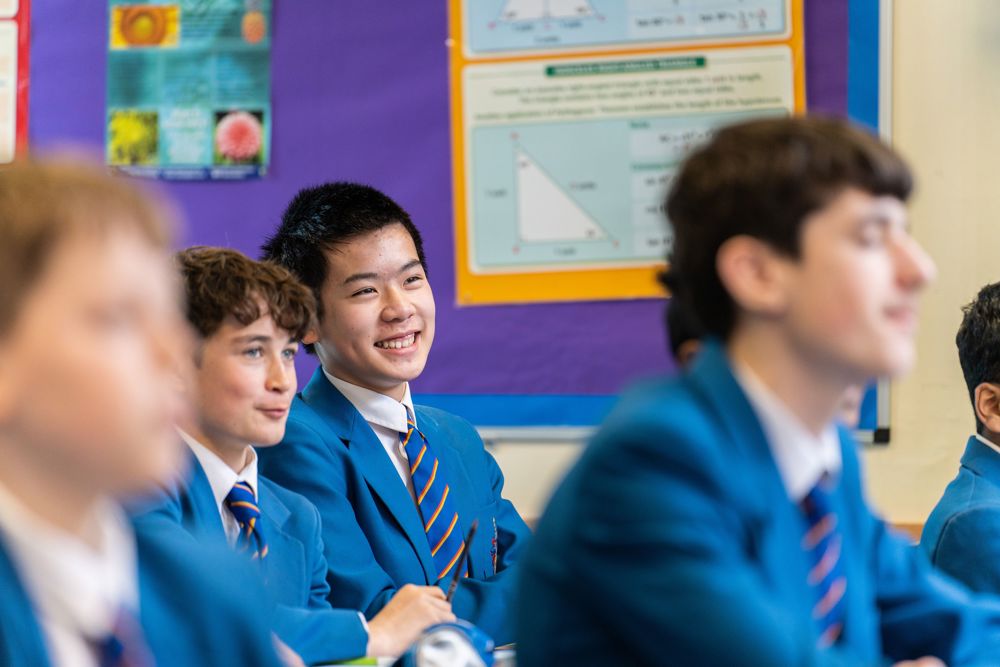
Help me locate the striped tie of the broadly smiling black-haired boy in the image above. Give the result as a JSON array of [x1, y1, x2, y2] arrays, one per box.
[[401, 411, 465, 581]]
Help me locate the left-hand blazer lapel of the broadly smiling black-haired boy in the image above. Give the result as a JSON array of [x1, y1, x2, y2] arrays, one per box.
[[302, 368, 437, 583]]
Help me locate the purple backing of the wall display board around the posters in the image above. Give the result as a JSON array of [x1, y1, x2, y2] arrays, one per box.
[[29, 0, 848, 423]]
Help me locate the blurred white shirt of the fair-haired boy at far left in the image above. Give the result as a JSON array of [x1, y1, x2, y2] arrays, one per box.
[[0, 487, 139, 667]]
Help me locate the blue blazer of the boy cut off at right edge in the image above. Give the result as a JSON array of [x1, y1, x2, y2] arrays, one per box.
[[920, 436, 1000, 593]]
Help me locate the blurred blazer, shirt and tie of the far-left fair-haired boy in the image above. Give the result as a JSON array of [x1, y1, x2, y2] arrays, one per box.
[[0, 488, 280, 667]]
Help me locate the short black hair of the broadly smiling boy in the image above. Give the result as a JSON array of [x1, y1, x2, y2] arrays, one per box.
[[261, 182, 427, 332]]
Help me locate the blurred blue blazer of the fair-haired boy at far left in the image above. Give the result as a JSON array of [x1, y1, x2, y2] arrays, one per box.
[[0, 524, 281, 667]]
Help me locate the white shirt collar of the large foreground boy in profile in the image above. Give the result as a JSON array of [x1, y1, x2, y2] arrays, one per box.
[[733, 363, 841, 502]]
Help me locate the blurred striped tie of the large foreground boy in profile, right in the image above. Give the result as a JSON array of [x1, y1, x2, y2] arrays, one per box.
[[802, 478, 847, 648]]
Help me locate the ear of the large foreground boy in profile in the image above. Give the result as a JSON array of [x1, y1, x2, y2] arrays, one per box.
[[715, 236, 789, 315]]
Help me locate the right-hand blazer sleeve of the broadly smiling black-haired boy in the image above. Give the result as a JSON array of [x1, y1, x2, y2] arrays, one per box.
[[450, 419, 531, 644]]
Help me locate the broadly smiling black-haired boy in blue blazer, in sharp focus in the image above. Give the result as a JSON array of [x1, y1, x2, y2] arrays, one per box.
[[260, 183, 528, 643]]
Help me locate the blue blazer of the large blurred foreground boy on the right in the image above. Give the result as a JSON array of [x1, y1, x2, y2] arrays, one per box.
[[517, 343, 1000, 667]]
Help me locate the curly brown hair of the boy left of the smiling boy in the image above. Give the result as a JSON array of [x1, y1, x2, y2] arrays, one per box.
[[175, 246, 315, 340]]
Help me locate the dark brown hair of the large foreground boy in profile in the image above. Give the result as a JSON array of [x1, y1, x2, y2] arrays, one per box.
[[661, 116, 913, 339]]
